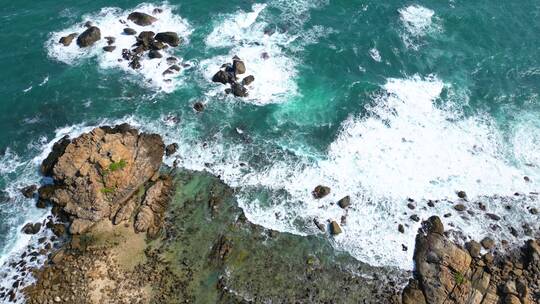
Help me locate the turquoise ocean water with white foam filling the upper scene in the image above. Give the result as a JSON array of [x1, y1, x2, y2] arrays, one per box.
[[0, 0, 540, 292]]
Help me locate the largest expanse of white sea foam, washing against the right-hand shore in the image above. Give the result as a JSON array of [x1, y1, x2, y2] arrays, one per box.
[[157, 76, 540, 269]]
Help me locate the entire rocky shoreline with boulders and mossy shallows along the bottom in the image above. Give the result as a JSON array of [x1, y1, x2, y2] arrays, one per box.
[[0, 124, 540, 304]]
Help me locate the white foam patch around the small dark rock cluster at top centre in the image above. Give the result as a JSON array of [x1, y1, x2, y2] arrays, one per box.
[[201, 4, 297, 104]]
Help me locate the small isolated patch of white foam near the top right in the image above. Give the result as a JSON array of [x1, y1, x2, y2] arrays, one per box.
[[398, 5, 441, 49]]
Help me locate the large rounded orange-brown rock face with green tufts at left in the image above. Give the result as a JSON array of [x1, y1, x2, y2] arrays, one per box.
[[51, 125, 165, 233]]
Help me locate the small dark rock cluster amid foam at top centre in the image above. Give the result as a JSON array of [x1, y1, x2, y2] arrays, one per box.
[[212, 56, 255, 97]]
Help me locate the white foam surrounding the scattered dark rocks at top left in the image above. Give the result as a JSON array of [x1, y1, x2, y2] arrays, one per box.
[[46, 4, 192, 92]]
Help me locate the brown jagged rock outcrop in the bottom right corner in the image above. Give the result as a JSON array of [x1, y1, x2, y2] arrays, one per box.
[[402, 216, 540, 304]]
